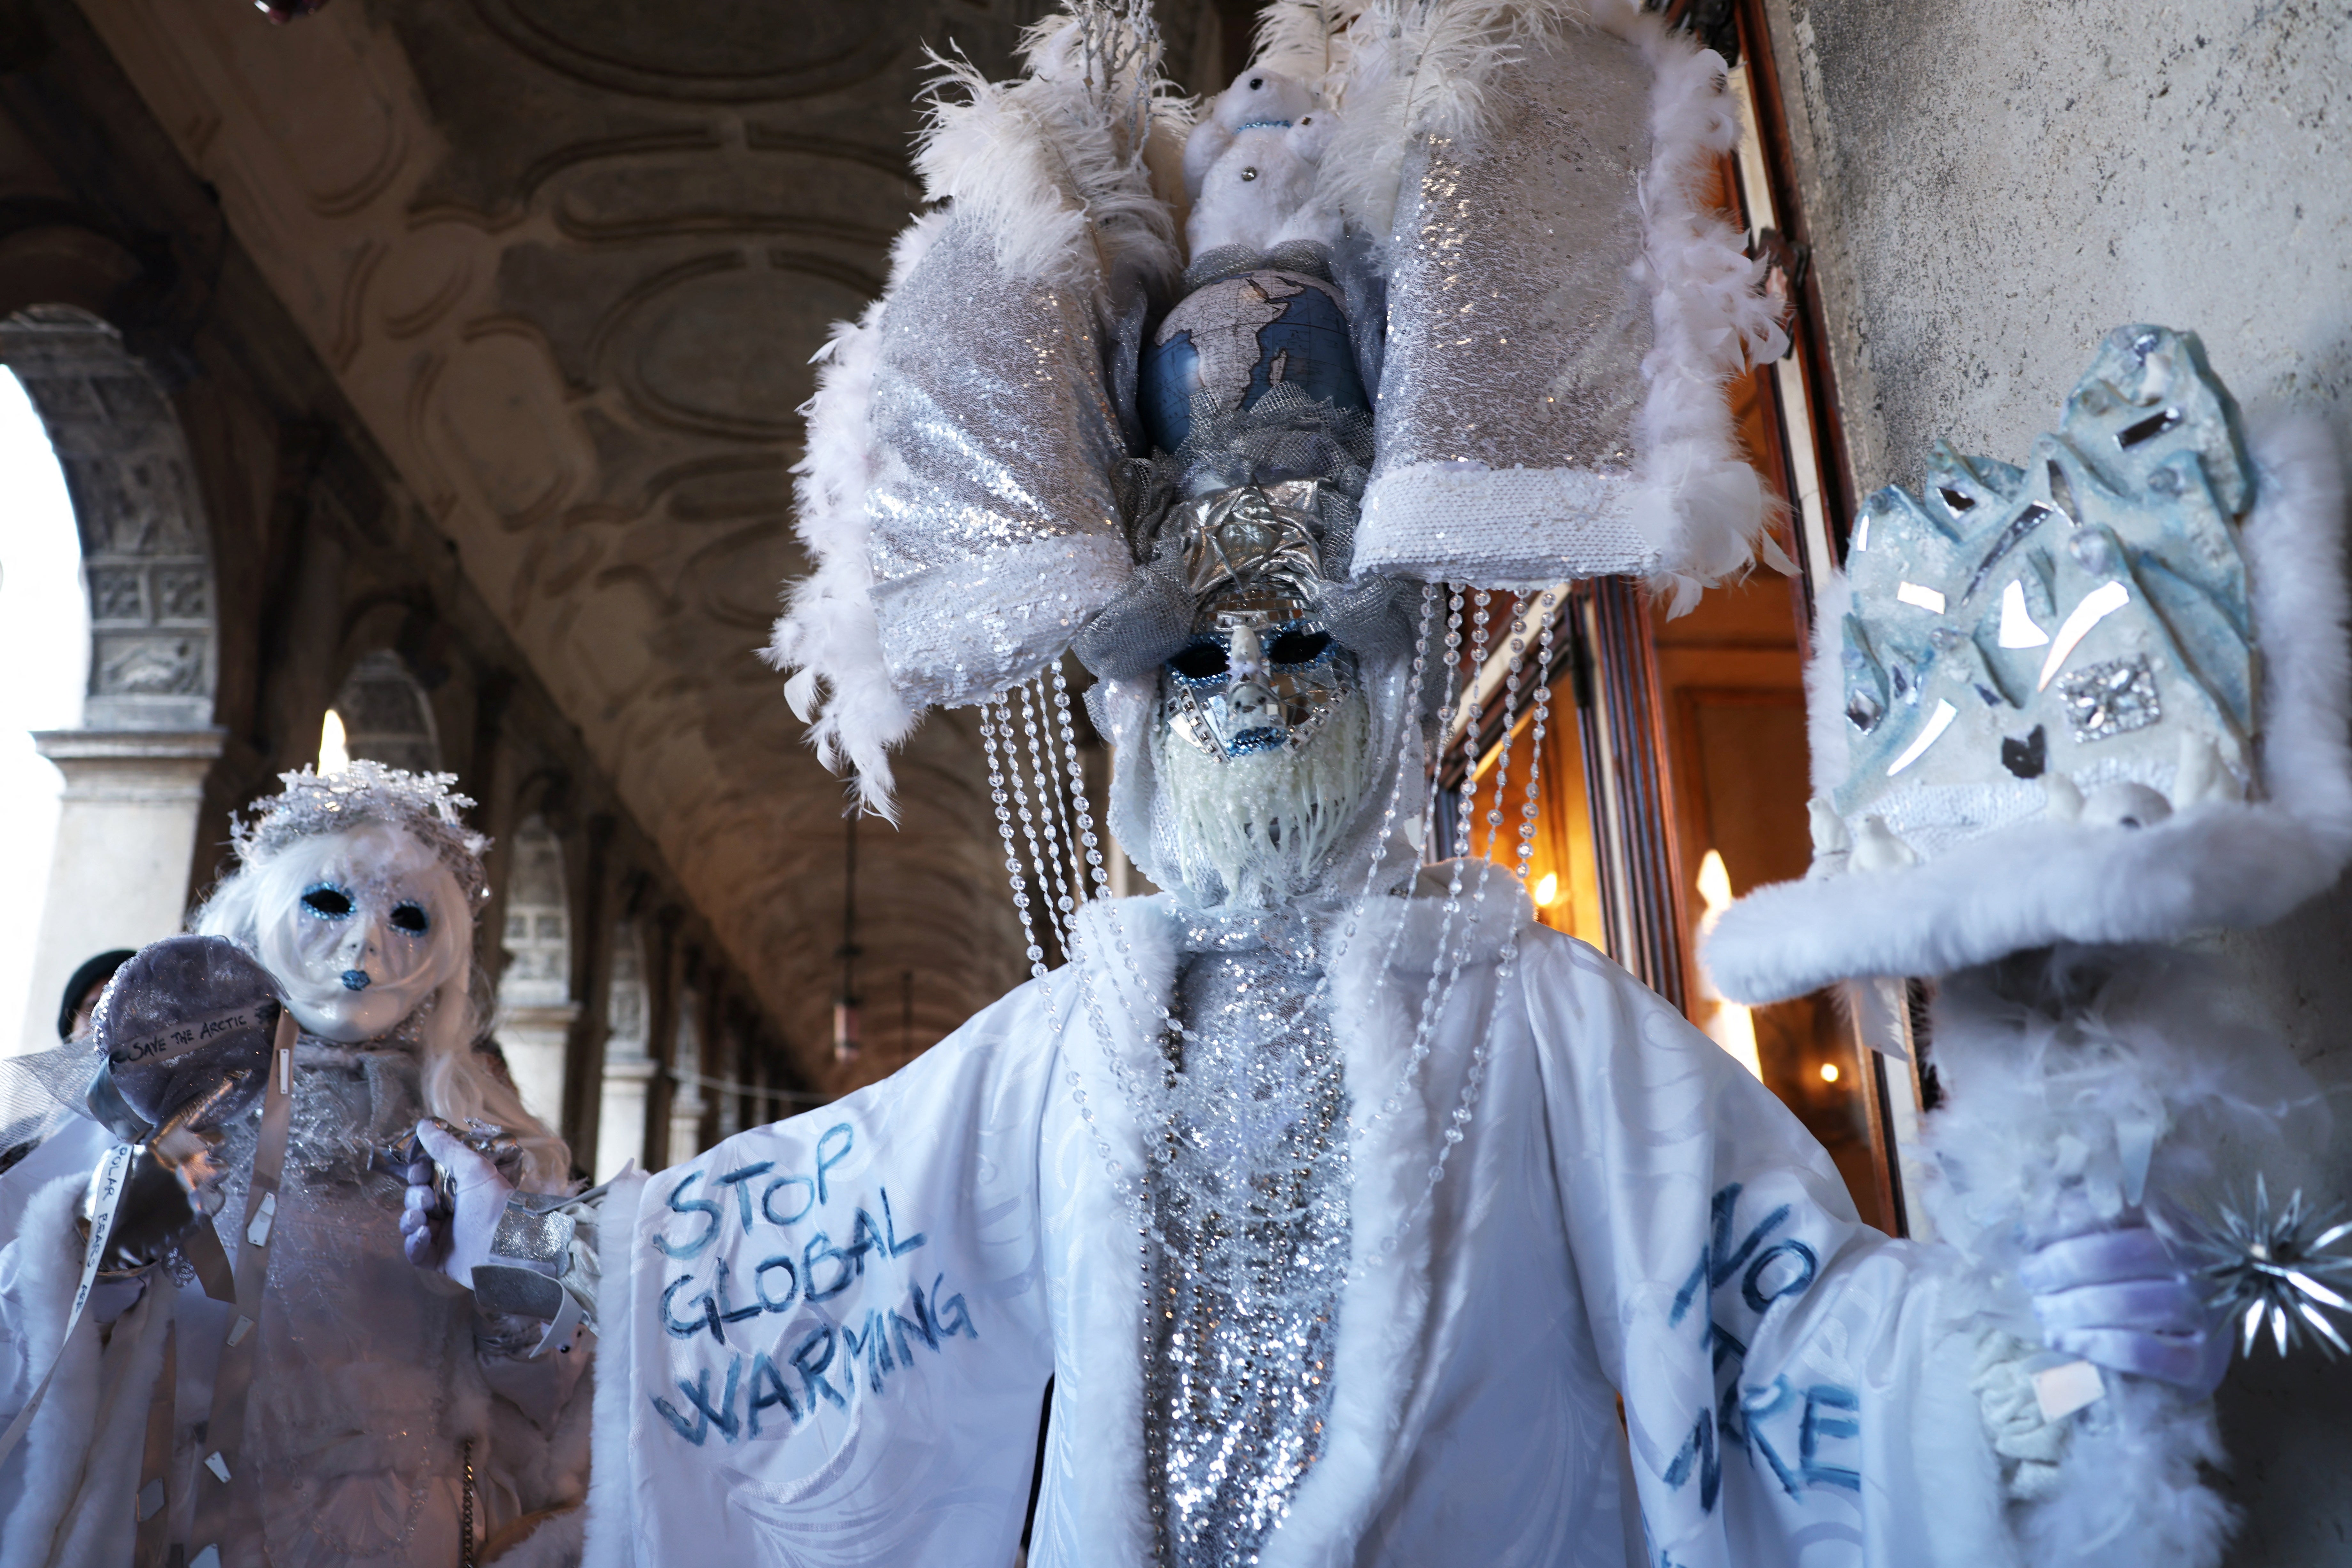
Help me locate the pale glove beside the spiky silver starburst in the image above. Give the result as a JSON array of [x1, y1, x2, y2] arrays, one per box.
[[2018, 1225, 2230, 1399]]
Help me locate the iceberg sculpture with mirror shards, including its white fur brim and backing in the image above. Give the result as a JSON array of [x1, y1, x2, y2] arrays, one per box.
[[1708, 324, 2352, 1004]]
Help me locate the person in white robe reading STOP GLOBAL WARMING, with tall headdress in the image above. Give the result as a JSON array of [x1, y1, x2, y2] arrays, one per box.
[[419, 0, 2213, 1568]]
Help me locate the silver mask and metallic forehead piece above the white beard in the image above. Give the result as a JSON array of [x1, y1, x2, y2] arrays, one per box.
[[1162, 479, 1355, 762]]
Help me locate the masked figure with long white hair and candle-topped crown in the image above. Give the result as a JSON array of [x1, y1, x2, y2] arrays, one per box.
[[0, 762, 588, 1568]]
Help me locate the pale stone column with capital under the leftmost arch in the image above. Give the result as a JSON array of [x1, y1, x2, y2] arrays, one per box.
[[21, 729, 228, 1046]]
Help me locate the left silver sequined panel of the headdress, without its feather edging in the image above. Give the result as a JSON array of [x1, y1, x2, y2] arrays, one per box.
[[866, 221, 1131, 708]]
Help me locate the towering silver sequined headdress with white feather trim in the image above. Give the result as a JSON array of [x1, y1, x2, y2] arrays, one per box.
[[771, 0, 1785, 811]]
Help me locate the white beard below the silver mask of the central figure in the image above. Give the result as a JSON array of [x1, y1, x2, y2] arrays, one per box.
[[1152, 684, 1371, 907]]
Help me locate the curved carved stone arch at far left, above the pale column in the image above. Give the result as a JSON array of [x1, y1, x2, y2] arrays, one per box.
[[0, 306, 219, 731]]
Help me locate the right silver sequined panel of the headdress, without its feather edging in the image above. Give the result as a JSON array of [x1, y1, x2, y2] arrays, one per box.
[[1357, 33, 1654, 581]]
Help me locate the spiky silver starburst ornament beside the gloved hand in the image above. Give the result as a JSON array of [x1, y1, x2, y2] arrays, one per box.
[[2185, 1176, 2352, 1356]]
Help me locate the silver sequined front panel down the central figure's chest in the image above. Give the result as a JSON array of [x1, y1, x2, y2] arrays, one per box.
[[1145, 917, 1350, 1568]]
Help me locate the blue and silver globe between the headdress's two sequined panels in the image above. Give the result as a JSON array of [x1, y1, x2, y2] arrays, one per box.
[[1138, 268, 1371, 451]]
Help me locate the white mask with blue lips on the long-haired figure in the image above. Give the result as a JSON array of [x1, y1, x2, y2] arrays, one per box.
[[259, 823, 473, 1044]]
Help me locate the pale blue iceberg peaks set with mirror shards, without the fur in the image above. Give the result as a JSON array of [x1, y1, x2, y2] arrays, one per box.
[[1830, 327, 2255, 827]]
